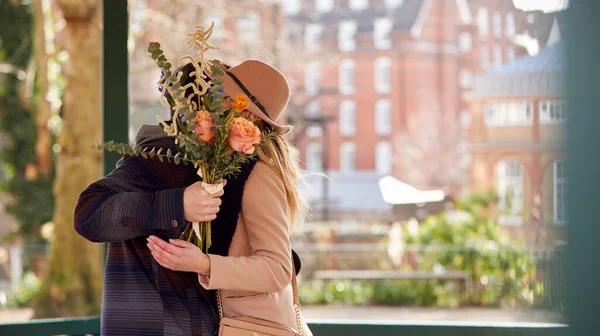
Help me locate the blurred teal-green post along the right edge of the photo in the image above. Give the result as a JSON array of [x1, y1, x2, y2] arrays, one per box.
[[563, 0, 600, 336]]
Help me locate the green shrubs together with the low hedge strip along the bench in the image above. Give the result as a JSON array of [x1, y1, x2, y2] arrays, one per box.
[[299, 191, 545, 307]]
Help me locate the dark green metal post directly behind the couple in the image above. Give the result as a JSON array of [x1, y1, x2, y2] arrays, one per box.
[[102, 0, 129, 255]]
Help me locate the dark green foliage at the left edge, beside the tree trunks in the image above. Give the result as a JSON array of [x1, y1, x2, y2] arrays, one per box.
[[0, 1, 54, 243]]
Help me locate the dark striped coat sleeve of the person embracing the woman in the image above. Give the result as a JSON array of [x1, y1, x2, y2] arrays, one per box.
[[74, 157, 185, 242]]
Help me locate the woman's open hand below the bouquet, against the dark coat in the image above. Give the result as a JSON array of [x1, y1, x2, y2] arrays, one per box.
[[148, 236, 210, 274]]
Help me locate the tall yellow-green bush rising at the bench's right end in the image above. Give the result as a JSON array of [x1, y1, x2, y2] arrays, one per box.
[[404, 192, 543, 307]]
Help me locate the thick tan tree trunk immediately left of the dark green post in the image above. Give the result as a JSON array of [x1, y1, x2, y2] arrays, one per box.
[[34, 0, 102, 317]]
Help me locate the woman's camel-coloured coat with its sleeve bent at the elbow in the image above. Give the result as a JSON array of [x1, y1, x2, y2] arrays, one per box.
[[198, 161, 297, 329]]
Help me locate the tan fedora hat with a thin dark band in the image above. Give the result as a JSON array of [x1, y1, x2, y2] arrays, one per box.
[[220, 60, 292, 134]]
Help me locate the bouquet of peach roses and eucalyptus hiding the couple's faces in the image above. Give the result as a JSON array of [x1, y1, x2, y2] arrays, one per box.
[[96, 23, 273, 252]]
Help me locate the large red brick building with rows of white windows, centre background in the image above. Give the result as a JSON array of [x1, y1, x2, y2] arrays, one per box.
[[286, 0, 540, 218]]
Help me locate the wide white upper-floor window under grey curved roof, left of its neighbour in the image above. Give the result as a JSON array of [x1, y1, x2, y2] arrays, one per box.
[[484, 101, 533, 127]]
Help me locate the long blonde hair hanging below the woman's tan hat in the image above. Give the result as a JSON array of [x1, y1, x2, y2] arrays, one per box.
[[257, 120, 308, 225]]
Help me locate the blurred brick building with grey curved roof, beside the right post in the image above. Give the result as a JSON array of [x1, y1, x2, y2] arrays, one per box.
[[468, 38, 568, 245]]
